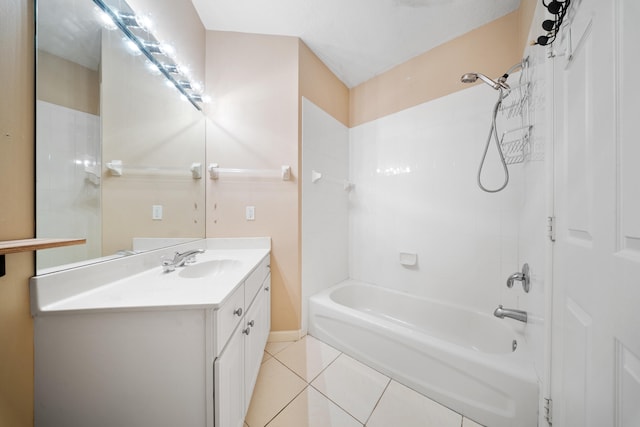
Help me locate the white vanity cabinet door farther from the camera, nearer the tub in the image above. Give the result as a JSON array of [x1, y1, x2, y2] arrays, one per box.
[[244, 277, 271, 411]]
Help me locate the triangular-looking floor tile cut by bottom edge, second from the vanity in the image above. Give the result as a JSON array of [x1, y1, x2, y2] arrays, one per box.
[[267, 387, 362, 427]]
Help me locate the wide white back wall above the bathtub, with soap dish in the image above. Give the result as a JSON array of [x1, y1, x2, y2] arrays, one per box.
[[349, 85, 523, 313]]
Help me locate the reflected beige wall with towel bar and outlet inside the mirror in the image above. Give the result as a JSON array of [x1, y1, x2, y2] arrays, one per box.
[[101, 30, 206, 256]]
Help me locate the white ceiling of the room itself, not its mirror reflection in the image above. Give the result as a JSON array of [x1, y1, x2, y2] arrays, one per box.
[[192, 0, 520, 87]]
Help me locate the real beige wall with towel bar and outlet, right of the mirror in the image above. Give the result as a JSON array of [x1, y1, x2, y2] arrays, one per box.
[[206, 31, 300, 331]]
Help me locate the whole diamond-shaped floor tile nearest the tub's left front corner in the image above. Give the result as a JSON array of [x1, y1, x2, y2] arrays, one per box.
[[274, 335, 340, 382]]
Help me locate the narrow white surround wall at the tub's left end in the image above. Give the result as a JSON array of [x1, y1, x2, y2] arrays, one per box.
[[301, 98, 349, 333]]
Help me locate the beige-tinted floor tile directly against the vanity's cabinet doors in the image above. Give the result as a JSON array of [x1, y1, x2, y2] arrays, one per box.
[[245, 358, 307, 427]]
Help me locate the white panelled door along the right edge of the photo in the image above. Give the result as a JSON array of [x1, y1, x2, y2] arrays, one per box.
[[551, 0, 640, 427]]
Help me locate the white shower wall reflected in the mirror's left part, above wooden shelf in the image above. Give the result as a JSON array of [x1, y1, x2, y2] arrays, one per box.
[[36, 101, 102, 270]]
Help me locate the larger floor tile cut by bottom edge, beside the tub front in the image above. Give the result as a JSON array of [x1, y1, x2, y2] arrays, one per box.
[[367, 381, 462, 427]]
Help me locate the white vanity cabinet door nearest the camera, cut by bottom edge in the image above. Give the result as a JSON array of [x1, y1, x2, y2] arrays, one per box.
[[213, 322, 246, 427]]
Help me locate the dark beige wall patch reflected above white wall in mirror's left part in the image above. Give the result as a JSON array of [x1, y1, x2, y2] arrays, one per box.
[[36, 50, 100, 116]]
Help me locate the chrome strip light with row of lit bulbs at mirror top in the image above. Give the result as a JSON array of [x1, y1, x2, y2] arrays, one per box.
[[93, 0, 206, 110]]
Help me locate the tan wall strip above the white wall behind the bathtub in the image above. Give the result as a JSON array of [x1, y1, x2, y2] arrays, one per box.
[[349, 6, 535, 127]]
